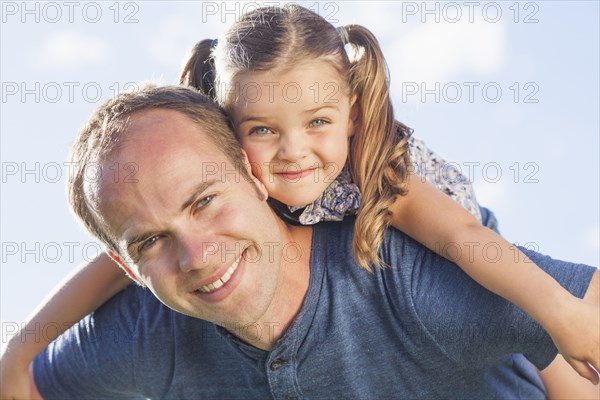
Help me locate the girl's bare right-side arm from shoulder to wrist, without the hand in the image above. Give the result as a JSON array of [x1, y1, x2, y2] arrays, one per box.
[[390, 175, 574, 328]]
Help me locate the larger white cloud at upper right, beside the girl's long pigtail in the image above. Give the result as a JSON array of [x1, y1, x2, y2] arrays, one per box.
[[386, 20, 506, 84]]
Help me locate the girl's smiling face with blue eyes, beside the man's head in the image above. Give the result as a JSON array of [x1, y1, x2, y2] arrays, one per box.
[[231, 60, 356, 206]]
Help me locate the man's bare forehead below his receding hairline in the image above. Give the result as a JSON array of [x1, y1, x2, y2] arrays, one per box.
[[94, 109, 232, 242]]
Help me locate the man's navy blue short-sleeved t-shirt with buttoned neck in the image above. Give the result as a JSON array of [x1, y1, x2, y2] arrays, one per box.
[[34, 218, 596, 399]]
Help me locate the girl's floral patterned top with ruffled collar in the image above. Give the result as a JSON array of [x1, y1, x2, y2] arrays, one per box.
[[269, 136, 481, 225]]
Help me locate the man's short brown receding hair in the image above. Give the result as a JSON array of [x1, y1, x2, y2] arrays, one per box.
[[67, 84, 250, 254]]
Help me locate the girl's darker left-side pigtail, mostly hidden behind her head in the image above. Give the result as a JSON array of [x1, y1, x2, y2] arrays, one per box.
[[179, 39, 216, 99]]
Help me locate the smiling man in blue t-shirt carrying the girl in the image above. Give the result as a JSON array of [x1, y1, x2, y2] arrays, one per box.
[[33, 87, 598, 399]]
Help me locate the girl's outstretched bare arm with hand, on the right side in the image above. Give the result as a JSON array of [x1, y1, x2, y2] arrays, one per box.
[[390, 174, 600, 383]]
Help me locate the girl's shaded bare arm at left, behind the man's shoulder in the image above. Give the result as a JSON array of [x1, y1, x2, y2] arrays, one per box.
[[0, 253, 132, 399]]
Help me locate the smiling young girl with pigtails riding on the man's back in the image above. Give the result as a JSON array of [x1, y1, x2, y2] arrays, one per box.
[[3, 5, 600, 396]]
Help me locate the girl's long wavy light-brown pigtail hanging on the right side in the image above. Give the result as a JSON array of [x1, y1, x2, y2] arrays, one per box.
[[346, 25, 410, 271]]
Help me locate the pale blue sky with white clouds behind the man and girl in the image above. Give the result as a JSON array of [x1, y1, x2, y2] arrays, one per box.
[[0, 1, 600, 342]]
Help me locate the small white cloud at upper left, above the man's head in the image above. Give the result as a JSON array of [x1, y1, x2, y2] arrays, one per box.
[[32, 31, 111, 70]]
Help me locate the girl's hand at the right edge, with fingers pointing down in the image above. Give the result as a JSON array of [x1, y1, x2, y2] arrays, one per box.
[[547, 297, 600, 385]]
